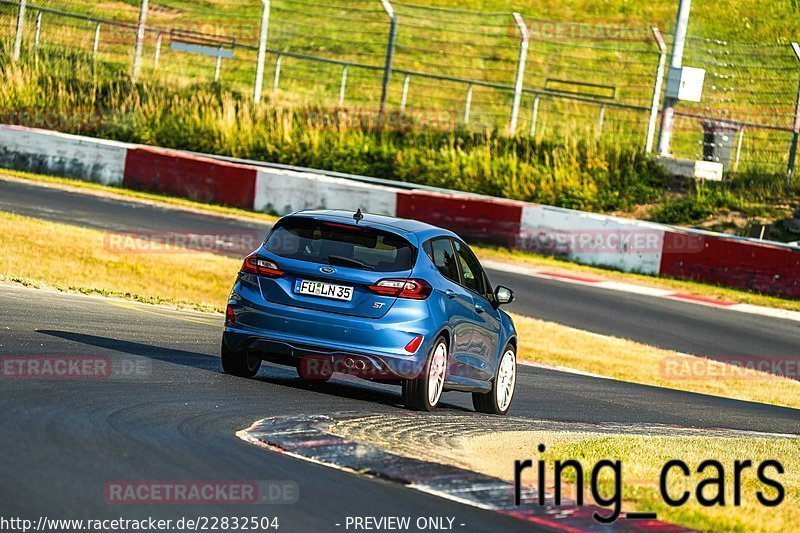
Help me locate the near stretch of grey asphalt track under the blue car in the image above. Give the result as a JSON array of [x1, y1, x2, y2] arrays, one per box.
[[0, 286, 800, 531]]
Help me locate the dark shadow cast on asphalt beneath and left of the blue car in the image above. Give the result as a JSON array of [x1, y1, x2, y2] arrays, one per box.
[[36, 329, 471, 412]]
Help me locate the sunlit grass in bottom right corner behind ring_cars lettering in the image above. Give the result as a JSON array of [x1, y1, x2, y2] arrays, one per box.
[[406, 431, 800, 532]]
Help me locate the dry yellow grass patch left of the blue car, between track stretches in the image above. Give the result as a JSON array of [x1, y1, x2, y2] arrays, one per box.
[[0, 209, 241, 311]]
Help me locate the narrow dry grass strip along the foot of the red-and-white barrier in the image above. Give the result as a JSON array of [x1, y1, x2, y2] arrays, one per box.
[[6, 169, 800, 311]]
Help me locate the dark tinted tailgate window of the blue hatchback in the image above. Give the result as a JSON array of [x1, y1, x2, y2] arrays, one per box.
[[266, 218, 415, 272]]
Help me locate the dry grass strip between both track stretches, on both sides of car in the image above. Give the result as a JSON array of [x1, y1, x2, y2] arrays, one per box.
[[0, 213, 800, 408]]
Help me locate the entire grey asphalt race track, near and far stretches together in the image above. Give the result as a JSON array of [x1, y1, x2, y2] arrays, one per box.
[[0, 181, 800, 532]]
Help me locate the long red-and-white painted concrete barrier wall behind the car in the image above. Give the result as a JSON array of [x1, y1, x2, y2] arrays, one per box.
[[0, 125, 800, 298]]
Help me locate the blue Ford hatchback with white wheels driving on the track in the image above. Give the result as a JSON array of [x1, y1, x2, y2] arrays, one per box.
[[222, 210, 517, 414]]
